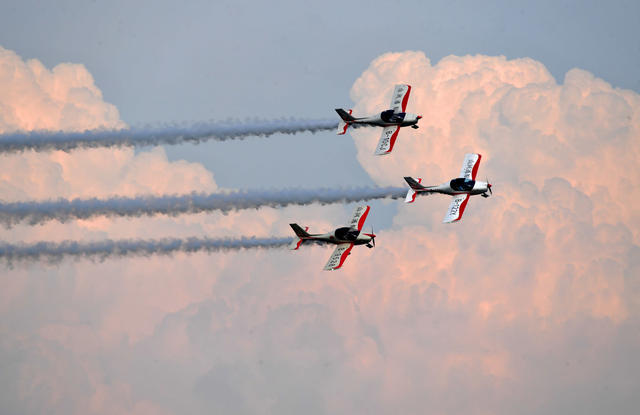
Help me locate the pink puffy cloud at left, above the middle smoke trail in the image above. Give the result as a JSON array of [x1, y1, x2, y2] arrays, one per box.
[[0, 47, 216, 201]]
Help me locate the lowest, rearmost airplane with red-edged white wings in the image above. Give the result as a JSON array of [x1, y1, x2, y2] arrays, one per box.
[[289, 205, 376, 271]]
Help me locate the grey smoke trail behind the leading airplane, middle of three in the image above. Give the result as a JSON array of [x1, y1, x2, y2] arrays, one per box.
[[0, 187, 407, 227]]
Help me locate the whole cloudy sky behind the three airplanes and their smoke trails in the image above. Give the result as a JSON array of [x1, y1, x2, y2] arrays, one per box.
[[0, 1, 640, 414]]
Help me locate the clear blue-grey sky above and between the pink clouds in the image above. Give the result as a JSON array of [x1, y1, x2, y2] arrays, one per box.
[[0, 0, 640, 191]]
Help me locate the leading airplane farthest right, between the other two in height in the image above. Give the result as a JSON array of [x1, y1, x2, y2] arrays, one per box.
[[404, 153, 493, 223]]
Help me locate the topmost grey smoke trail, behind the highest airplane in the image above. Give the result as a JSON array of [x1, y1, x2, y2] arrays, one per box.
[[0, 119, 338, 153]]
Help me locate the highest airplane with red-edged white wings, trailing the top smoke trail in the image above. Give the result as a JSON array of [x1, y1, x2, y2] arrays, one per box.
[[336, 85, 422, 156]]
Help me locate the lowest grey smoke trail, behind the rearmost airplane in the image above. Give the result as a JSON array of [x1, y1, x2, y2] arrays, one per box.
[[0, 237, 293, 266]]
